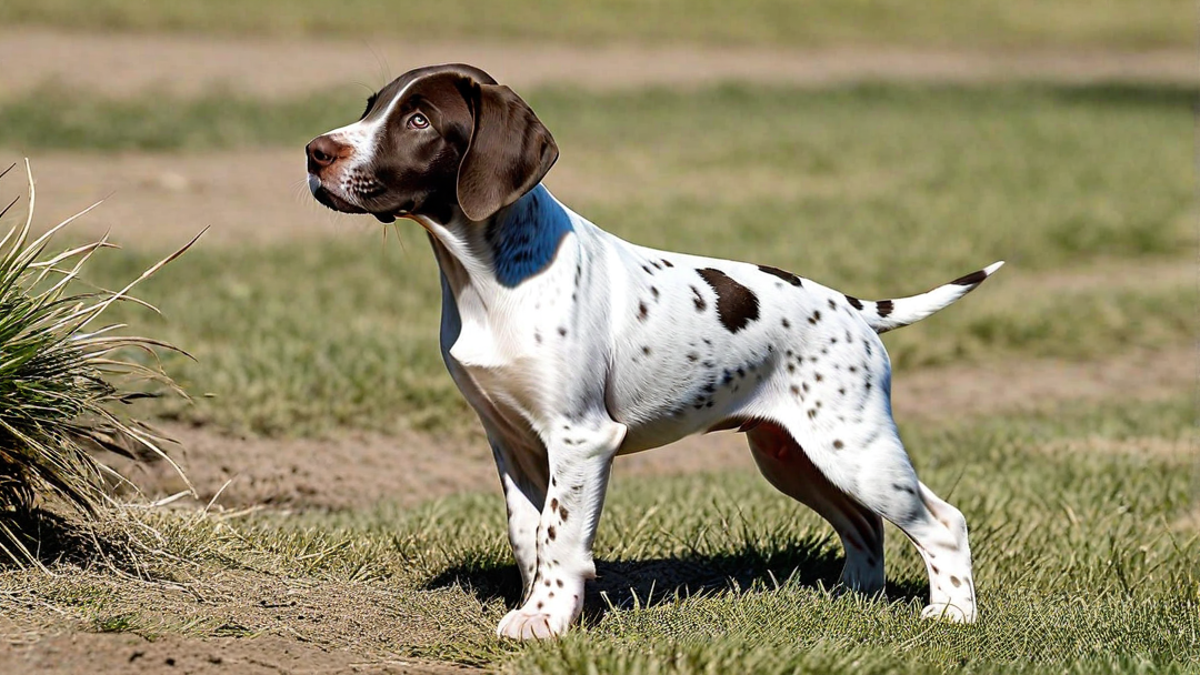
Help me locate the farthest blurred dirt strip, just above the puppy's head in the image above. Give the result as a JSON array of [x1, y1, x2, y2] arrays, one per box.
[[0, 28, 1200, 96]]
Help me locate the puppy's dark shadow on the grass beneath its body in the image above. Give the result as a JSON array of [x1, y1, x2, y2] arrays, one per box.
[[425, 534, 928, 622]]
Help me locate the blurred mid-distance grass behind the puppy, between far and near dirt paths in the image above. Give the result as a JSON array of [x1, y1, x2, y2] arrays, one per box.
[[0, 84, 1200, 435]]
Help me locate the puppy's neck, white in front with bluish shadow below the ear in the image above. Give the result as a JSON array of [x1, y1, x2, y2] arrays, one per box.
[[419, 185, 574, 304]]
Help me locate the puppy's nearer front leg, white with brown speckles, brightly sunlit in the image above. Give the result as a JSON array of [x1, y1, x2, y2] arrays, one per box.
[[497, 417, 625, 640]]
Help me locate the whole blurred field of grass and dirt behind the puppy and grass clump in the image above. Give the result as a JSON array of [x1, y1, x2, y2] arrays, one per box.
[[0, 0, 1200, 503]]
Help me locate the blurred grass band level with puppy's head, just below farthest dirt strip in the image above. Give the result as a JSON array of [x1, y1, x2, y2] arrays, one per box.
[[0, 84, 1196, 276]]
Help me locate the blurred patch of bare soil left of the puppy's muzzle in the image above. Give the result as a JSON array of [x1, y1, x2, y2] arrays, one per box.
[[12, 148, 355, 250]]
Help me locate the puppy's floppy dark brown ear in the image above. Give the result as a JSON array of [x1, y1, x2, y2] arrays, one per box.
[[457, 82, 558, 221]]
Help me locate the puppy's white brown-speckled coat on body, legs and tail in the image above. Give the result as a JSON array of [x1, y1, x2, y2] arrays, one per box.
[[309, 102, 998, 639]]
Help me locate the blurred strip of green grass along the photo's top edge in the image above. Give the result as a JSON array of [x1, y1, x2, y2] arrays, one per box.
[[0, 0, 1194, 49]]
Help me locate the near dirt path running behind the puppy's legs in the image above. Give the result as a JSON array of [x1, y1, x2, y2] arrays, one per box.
[[114, 347, 1200, 509]]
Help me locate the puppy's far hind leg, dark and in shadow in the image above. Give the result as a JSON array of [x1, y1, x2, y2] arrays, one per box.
[[746, 422, 884, 595]]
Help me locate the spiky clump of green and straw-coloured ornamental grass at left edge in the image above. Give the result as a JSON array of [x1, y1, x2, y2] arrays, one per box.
[[0, 161, 196, 567]]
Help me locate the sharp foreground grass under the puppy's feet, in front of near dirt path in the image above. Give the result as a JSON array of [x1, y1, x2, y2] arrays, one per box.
[[0, 398, 1200, 674]]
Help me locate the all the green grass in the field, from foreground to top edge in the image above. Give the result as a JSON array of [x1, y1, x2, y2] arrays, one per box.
[[0, 6, 1200, 675]]
